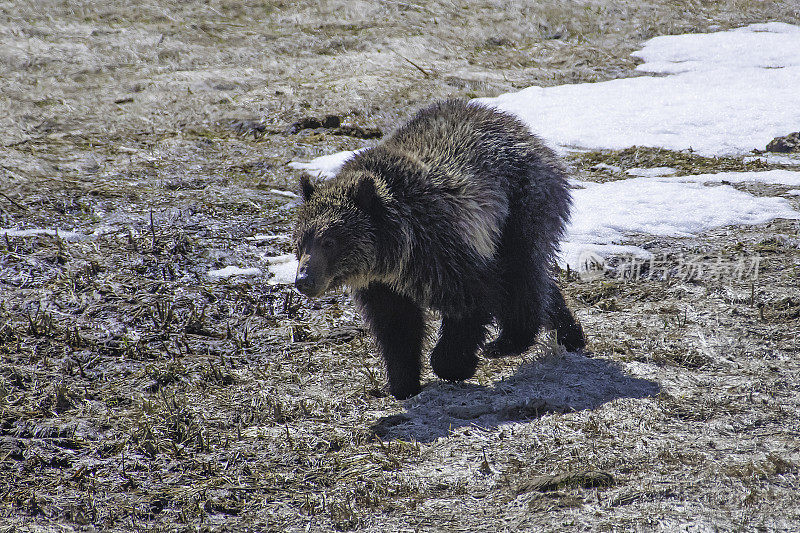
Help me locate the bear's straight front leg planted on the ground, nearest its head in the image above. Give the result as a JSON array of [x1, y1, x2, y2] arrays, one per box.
[[354, 283, 425, 400]]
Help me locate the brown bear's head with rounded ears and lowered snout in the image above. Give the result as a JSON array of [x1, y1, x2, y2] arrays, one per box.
[[294, 174, 381, 297]]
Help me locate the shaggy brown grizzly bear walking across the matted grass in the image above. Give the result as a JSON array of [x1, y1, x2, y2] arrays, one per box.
[[294, 100, 585, 399]]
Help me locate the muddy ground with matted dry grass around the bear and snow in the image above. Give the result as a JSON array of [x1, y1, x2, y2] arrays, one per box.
[[0, 0, 800, 531]]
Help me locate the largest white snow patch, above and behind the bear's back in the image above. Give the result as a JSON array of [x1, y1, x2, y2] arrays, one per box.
[[477, 22, 800, 156]]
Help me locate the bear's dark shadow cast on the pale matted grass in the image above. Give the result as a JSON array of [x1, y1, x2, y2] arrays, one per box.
[[372, 352, 660, 442]]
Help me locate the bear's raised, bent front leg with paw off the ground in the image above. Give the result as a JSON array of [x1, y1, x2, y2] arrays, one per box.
[[431, 314, 488, 381]]
